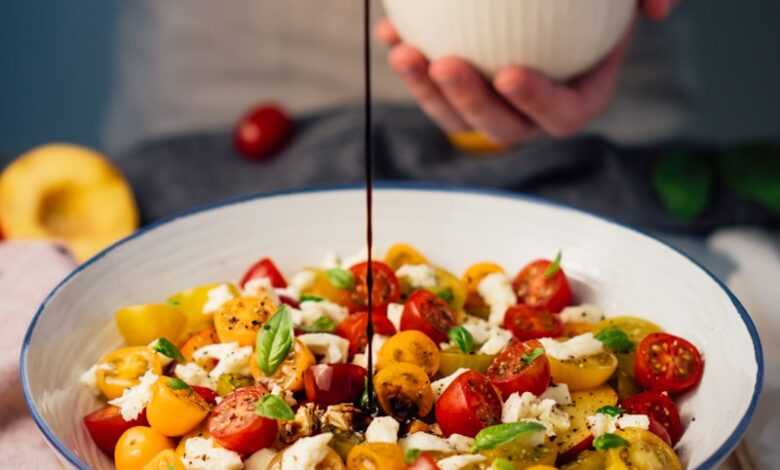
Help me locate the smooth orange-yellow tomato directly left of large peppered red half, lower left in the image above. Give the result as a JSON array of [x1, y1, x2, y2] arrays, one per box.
[[146, 377, 209, 437]]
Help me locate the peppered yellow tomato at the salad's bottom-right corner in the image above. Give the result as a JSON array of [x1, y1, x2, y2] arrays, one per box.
[[607, 428, 682, 470]]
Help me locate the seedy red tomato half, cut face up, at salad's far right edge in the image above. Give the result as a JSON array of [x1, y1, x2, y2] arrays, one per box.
[[634, 333, 704, 395]]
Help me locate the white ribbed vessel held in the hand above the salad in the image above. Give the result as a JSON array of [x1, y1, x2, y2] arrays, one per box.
[[384, 0, 637, 80]]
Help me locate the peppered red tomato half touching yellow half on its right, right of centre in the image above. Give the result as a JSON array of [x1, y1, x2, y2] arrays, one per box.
[[485, 340, 550, 397]]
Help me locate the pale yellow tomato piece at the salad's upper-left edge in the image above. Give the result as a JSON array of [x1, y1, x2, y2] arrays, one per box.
[[115, 304, 187, 346]]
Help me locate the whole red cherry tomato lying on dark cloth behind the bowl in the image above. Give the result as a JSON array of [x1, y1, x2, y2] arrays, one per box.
[[233, 104, 292, 160]]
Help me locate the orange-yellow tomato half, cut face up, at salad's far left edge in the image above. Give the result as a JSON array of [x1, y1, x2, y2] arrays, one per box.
[[95, 346, 162, 400]]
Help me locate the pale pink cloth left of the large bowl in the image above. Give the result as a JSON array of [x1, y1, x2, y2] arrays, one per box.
[[0, 242, 76, 469]]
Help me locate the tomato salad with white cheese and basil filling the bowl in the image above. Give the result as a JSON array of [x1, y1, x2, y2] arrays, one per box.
[[81, 244, 704, 470]]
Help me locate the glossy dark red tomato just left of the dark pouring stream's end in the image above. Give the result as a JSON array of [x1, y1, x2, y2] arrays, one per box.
[[303, 364, 366, 406]]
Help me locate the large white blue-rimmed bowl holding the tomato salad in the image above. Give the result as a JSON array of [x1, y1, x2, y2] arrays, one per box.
[[21, 184, 763, 469]]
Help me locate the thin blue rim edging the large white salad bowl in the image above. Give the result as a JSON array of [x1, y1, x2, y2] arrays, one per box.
[[19, 181, 764, 470]]
